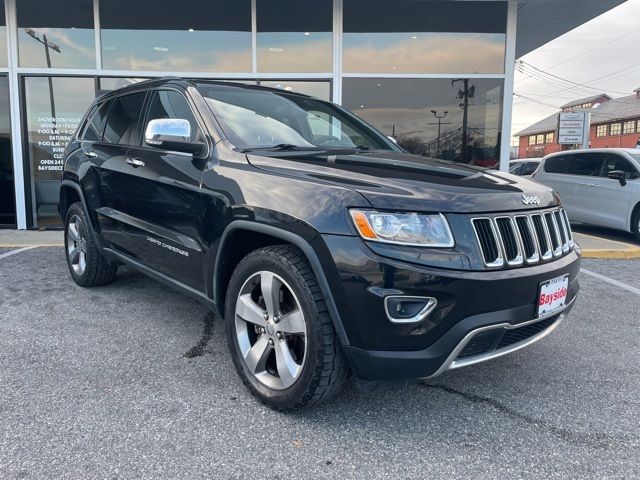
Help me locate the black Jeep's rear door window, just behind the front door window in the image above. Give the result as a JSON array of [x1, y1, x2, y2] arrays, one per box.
[[104, 92, 145, 145]]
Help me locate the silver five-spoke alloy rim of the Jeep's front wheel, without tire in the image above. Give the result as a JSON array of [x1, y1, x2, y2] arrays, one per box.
[[235, 271, 307, 390]]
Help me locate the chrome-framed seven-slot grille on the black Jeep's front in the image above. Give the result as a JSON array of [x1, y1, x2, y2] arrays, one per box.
[[471, 208, 574, 268]]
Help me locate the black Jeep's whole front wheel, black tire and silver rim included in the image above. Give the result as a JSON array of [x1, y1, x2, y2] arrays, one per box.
[[225, 245, 349, 411]]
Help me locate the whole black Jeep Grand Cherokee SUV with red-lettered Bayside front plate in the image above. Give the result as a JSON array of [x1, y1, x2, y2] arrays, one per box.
[[60, 78, 580, 409]]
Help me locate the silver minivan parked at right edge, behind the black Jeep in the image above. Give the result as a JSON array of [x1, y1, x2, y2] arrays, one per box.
[[533, 148, 640, 241]]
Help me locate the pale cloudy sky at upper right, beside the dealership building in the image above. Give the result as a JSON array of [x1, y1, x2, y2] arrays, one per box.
[[512, 0, 640, 141]]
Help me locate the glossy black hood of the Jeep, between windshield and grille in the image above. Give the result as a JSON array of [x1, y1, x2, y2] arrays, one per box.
[[247, 152, 559, 213]]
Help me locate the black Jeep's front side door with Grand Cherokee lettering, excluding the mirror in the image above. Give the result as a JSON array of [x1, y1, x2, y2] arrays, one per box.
[[126, 88, 206, 291]]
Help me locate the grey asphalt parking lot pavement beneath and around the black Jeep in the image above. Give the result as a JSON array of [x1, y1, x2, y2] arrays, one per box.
[[0, 248, 640, 479]]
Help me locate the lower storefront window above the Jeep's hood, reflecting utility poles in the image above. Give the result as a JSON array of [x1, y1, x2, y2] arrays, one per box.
[[342, 78, 503, 167]]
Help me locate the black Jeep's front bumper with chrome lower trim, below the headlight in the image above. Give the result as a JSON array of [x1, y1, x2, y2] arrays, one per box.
[[316, 236, 580, 381]]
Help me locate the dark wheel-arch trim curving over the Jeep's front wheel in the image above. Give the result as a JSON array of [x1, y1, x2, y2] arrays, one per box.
[[213, 220, 349, 346]]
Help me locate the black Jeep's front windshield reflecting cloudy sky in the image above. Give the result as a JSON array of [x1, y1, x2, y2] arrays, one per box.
[[198, 83, 400, 151]]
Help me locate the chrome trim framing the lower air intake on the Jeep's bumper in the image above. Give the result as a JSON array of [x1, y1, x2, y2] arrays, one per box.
[[427, 297, 576, 378]]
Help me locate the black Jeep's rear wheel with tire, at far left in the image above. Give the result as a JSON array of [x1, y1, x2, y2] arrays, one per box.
[[64, 202, 118, 287]]
